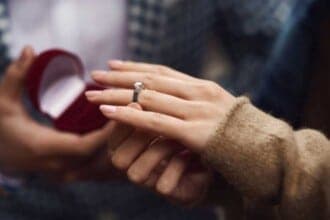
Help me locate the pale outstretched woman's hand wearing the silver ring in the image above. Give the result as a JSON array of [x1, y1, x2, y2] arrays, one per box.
[[86, 61, 235, 152]]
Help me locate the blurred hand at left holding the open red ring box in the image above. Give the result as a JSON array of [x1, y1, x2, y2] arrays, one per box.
[[0, 47, 113, 173]]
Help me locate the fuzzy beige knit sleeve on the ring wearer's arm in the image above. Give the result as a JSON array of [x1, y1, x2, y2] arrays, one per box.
[[203, 98, 330, 219]]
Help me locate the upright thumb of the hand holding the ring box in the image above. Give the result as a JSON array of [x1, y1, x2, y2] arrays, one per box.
[[1, 46, 35, 98]]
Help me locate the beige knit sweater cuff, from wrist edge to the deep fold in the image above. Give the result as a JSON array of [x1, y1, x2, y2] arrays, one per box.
[[202, 97, 292, 199]]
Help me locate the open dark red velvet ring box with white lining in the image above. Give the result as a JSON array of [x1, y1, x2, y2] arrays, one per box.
[[26, 49, 107, 134]]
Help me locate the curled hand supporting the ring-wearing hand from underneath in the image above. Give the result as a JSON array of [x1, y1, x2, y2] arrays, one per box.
[[110, 104, 212, 205]]
